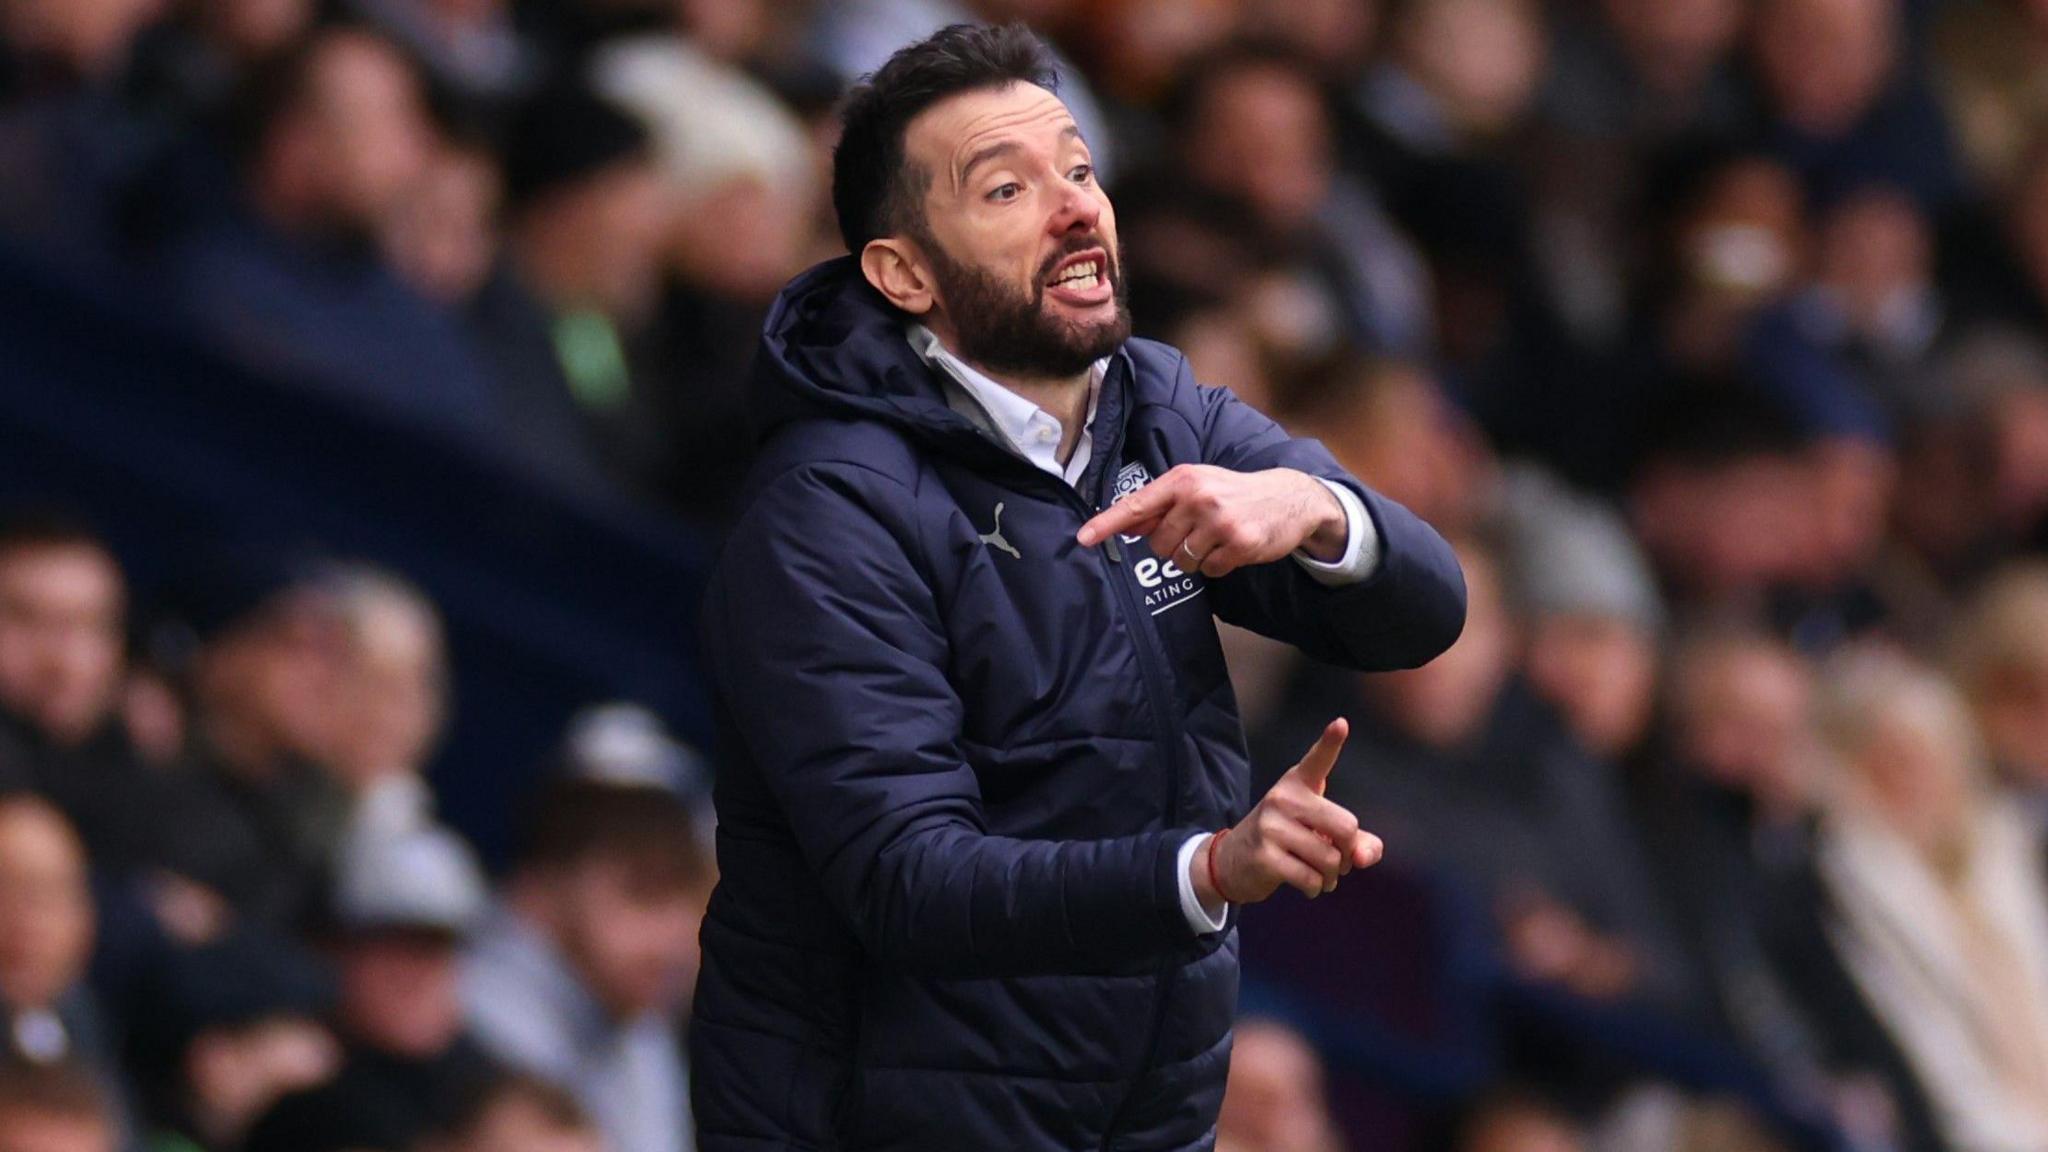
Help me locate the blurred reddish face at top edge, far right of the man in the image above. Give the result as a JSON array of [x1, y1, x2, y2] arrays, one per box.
[[1757, 0, 1898, 135]]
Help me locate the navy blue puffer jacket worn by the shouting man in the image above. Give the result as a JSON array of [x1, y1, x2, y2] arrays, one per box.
[[692, 258, 1464, 1152]]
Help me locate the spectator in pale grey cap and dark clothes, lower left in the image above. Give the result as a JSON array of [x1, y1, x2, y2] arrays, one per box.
[[244, 832, 499, 1152]]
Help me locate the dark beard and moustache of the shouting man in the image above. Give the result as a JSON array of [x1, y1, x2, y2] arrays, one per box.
[[922, 227, 1130, 379]]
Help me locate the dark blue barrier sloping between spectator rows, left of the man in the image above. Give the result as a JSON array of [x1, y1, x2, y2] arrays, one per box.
[[0, 241, 711, 859]]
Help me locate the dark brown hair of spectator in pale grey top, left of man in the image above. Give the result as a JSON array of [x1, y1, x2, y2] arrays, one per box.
[[518, 779, 711, 894]]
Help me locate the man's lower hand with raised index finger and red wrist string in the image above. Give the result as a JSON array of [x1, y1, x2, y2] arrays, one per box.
[[1188, 719, 1384, 908]]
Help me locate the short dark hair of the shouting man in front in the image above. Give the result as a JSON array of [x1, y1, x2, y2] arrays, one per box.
[[831, 25, 1059, 256]]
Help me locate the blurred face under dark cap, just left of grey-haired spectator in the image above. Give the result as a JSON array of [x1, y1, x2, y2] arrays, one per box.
[[197, 590, 346, 769]]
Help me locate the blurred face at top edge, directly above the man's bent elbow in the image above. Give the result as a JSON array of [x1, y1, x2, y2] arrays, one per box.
[[1395, 0, 1544, 135]]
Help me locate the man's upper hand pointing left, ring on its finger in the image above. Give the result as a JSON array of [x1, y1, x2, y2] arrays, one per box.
[[1077, 463, 1348, 578]]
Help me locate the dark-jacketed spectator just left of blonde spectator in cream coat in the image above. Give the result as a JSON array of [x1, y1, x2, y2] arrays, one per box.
[[1636, 629, 1935, 1148]]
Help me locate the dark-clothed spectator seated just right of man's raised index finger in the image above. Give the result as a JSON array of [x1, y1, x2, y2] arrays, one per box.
[[1253, 545, 1694, 1015]]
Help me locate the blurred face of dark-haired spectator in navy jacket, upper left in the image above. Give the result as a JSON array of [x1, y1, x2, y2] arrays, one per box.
[[264, 31, 432, 230]]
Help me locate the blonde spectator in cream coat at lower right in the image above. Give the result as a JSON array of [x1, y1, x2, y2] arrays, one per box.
[[1819, 650, 2048, 1152]]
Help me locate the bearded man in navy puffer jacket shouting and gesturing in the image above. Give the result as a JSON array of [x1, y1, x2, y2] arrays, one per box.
[[690, 27, 1464, 1152]]
